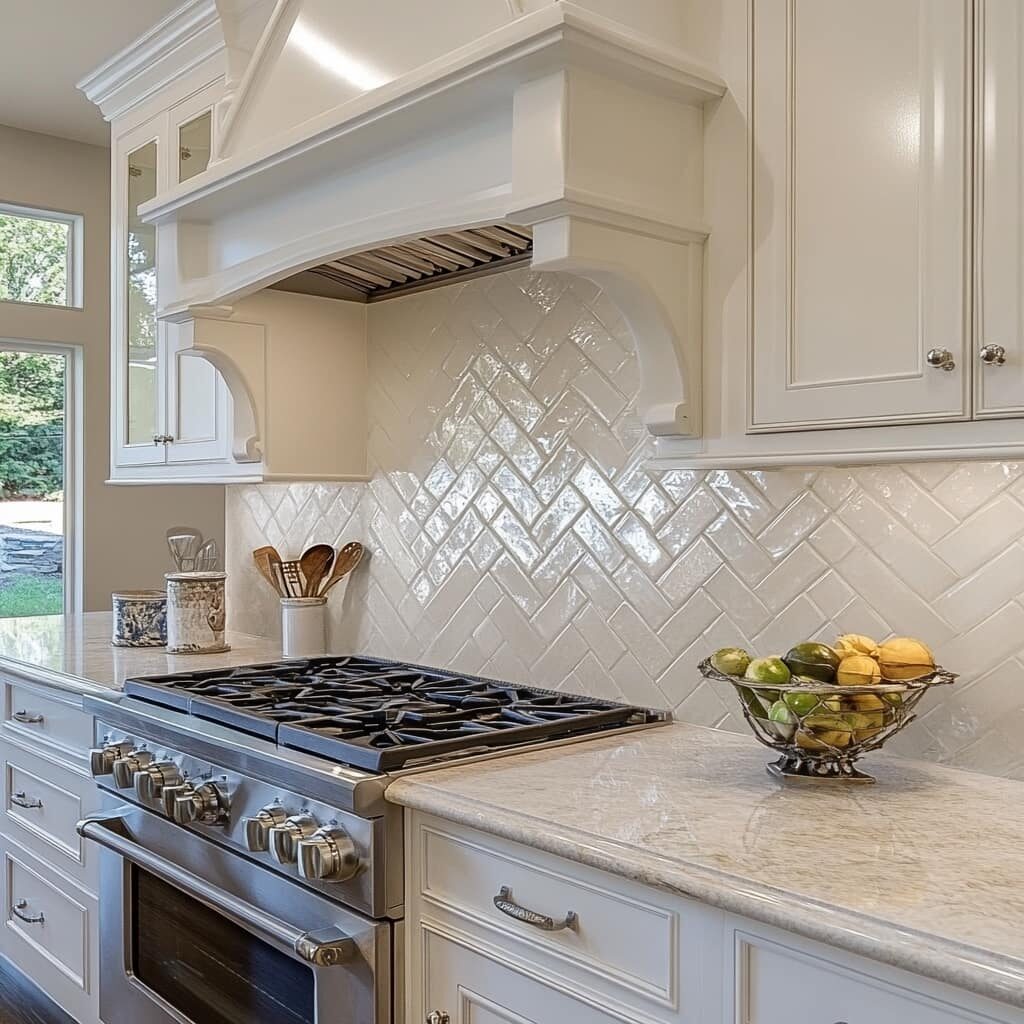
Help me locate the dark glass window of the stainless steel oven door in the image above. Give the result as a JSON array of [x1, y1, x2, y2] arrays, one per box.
[[130, 866, 316, 1024]]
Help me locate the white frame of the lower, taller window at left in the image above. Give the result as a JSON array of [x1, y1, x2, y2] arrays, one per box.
[[0, 339, 85, 615]]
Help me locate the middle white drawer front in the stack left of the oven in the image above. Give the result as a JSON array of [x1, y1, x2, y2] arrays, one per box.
[[0, 744, 99, 889]]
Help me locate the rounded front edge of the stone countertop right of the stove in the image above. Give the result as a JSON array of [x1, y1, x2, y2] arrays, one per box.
[[385, 776, 1024, 1009]]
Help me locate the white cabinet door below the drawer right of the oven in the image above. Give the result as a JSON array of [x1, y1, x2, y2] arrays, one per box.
[[421, 928, 624, 1024]]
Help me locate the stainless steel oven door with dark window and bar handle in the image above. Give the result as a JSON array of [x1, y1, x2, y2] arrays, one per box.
[[79, 806, 391, 1024]]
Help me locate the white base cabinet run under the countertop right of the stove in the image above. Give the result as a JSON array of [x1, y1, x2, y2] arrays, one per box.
[[406, 812, 1024, 1024]]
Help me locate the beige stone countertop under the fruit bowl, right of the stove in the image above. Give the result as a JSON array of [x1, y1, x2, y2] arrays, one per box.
[[387, 723, 1024, 1007]]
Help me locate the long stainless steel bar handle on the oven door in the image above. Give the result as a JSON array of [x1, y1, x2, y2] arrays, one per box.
[[77, 807, 355, 967]]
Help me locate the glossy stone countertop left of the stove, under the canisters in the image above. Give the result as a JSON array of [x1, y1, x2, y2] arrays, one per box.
[[0, 611, 282, 693]]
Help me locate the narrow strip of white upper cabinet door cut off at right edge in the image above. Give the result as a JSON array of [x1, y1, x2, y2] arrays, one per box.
[[974, 0, 1024, 417]]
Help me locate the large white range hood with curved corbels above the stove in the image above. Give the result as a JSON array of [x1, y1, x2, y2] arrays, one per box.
[[141, 0, 725, 459]]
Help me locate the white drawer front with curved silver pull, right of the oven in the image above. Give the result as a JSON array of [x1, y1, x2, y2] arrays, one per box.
[[419, 824, 680, 1009]]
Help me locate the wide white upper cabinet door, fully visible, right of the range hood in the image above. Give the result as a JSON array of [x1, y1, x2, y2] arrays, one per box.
[[749, 0, 966, 432]]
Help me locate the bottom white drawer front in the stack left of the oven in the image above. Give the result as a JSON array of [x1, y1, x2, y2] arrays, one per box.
[[4, 849, 89, 991]]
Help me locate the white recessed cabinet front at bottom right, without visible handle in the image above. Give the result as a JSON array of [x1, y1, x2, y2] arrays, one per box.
[[736, 933, 993, 1024]]
